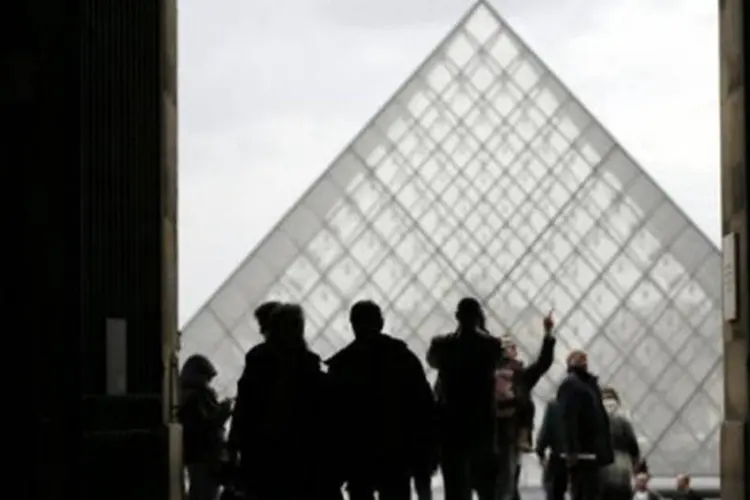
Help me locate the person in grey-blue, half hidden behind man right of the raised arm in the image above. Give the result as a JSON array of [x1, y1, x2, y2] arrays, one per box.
[[535, 399, 568, 500]]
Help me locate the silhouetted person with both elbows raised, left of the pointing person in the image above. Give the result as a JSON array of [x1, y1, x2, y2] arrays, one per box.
[[427, 298, 504, 500]]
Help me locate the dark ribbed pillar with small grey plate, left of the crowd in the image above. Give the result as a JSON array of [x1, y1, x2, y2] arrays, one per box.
[[78, 0, 181, 500]]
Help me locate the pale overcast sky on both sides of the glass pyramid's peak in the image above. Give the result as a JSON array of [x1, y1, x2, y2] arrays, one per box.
[[179, 0, 720, 323]]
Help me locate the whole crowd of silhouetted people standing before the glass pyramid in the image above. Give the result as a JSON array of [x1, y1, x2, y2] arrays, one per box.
[[178, 298, 708, 500]]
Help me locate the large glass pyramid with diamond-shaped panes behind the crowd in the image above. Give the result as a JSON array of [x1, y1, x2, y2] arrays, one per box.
[[181, 2, 722, 484]]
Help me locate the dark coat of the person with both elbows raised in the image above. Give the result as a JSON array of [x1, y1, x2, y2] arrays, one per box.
[[427, 331, 505, 448]]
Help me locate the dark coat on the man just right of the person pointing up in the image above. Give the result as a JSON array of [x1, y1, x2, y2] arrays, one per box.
[[557, 370, 614, 466]]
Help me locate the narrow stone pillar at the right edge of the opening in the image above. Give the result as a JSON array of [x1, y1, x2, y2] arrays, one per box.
[[719, 0, 750, 500]]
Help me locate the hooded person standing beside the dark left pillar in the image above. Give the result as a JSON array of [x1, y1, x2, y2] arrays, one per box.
[[178, 354, 232, 500]]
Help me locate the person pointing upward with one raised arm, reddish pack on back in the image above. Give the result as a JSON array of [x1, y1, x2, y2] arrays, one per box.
[[497, 313, 556, 500]]
